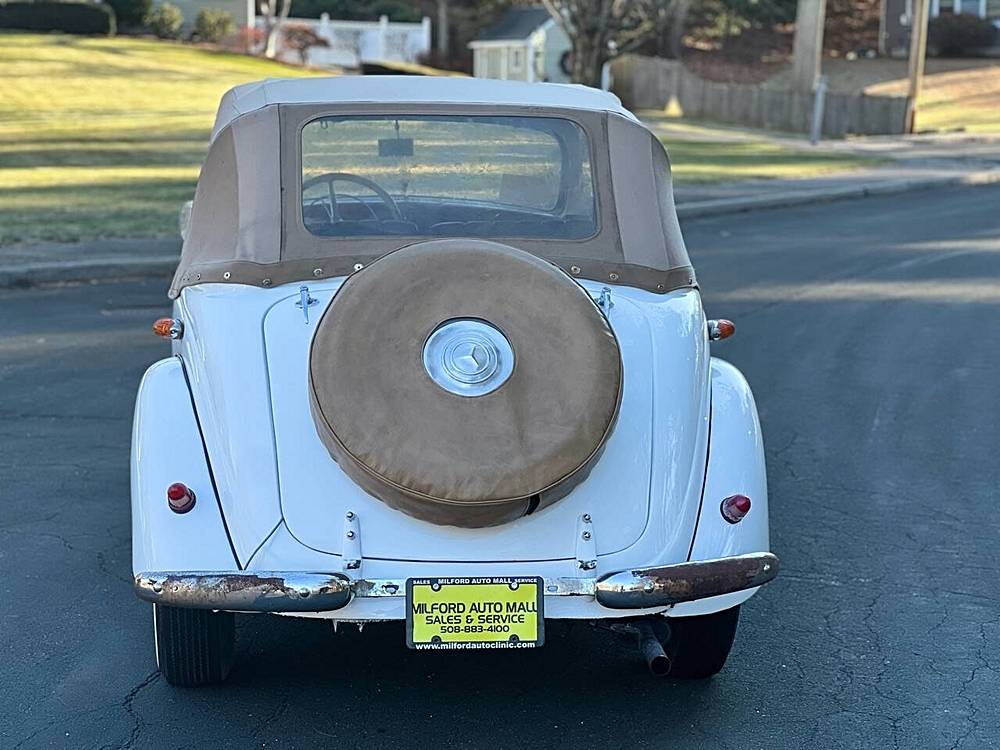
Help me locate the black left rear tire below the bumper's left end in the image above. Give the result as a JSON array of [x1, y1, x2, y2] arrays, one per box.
[[153, 604, 236, 687]]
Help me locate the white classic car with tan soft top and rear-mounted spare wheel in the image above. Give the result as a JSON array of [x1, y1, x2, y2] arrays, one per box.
[[131, 77, 778, 685]]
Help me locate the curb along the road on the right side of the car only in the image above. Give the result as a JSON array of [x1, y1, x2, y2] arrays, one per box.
[[677, 169, 1000, 219]]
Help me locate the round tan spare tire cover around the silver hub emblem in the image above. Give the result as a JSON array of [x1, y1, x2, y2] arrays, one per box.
[[309, 239, 622, 527]]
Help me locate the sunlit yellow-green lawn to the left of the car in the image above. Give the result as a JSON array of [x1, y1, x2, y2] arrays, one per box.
[[0, 34, 320, 244]]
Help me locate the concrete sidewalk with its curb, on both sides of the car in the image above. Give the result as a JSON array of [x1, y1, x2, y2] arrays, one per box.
[[0, 131, 1000, 289]]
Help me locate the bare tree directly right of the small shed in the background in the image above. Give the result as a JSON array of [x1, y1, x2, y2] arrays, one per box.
[[543, 0, 690, 86]]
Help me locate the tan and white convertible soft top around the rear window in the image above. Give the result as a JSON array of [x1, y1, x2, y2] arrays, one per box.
[[170, 76, 695, 297]]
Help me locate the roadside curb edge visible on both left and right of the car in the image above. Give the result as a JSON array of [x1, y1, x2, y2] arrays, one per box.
[[0, 169, 1000, 289]]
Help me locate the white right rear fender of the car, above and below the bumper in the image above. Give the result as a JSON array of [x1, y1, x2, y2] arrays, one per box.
[[670, 357, 770, 617]]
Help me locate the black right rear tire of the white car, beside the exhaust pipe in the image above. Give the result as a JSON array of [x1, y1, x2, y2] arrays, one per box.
[[664, 606, 740, 679]]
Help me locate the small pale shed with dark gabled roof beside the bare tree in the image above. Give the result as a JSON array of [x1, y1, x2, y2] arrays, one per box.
[[469, 5, 571, 83]]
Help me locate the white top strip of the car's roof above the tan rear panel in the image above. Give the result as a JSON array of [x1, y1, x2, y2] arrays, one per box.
[[212, 76, 635, 140]]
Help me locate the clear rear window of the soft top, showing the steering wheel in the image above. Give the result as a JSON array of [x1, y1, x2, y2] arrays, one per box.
[[301, 115, 598, 240]]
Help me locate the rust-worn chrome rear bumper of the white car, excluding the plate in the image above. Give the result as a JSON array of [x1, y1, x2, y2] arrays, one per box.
[[135, 552, 778, 612]]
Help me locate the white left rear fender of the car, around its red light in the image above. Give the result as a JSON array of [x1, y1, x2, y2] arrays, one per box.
[[131, 357, 239, 574]]
